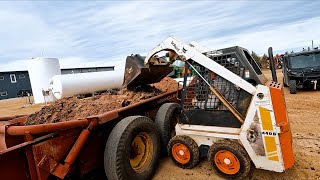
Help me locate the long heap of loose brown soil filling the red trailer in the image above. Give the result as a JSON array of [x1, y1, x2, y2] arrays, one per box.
[[25, 77, 177, 125]]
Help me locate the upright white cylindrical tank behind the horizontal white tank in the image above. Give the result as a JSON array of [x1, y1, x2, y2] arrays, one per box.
[[28, 57, 61, 104]]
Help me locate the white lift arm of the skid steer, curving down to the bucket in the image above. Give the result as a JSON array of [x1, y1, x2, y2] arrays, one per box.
[[144, 37, 256, 94]]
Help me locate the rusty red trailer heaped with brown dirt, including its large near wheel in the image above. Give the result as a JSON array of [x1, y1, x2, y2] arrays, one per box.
[[0, 77, 178, 180]]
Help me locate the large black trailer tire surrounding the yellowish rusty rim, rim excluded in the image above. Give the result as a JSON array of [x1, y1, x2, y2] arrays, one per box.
[[104, 116, 160, 180]]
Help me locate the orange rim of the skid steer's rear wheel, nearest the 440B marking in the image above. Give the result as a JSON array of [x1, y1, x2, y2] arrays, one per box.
[[214, 150, 240, 175]]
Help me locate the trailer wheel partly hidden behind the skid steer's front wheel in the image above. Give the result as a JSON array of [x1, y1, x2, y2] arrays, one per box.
[[155, 103, 181, 154]]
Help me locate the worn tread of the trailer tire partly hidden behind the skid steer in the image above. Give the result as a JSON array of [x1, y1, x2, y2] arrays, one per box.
[[155, 103, 180, 150]]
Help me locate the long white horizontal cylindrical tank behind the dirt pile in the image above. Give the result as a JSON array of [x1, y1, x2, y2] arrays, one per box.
[[50, 69, 124, 99]]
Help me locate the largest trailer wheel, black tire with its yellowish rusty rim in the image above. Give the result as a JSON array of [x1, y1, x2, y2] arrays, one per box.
[[104, 116, 160, 180]]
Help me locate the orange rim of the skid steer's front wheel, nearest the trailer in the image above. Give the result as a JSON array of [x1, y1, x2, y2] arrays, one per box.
[[172, 143, 190, 164]]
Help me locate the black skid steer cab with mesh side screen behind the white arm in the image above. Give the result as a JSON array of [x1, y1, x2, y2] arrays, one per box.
[[180, 46, 267, 128]]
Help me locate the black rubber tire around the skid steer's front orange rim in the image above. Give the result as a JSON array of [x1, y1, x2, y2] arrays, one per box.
[[168, 135, 200, 169]]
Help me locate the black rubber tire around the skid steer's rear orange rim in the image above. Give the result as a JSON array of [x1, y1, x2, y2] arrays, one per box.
[[208, 140, 252, 179]]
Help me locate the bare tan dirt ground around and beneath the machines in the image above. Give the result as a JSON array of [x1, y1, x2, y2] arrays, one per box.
[[0, 70, 320, 180]]
